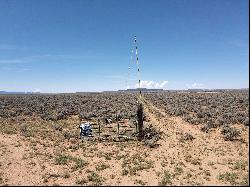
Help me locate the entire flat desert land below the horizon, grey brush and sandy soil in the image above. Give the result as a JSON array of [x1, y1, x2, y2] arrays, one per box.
[[0, 90, 249, 185]]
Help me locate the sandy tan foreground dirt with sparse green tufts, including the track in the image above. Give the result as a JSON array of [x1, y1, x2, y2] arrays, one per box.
[[0, 98, 249, 185]]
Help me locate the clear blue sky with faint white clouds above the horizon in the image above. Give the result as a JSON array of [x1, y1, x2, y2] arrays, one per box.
[[0, 0, 249, 92]]
